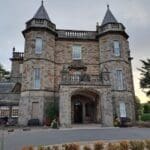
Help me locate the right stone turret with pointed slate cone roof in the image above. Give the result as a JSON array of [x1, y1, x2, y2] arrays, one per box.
[[97, 5, 134, 122]]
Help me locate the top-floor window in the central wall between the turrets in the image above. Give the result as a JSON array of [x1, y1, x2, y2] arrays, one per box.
[[72, 45, 82, 60]]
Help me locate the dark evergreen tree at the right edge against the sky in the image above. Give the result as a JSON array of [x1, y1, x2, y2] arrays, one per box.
[[138, 59, 150, 96]]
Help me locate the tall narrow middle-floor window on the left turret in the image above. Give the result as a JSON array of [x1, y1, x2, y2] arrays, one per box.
[[34, 68, 40, 89]]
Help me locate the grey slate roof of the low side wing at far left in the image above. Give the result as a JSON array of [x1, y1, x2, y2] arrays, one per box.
[[0, 82, 15, 93]]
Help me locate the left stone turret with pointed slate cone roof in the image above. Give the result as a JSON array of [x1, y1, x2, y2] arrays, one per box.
[[19, 1, 56, 125]]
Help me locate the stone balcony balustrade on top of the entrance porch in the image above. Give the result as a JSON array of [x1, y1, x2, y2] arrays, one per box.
[[61, 73, 110, 86]]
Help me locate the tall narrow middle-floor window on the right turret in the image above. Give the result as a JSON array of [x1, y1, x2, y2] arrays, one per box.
[[116, 70, 123, 90]]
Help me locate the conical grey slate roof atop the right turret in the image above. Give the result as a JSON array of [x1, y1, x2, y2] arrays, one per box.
[[101, 5, 118, 25]]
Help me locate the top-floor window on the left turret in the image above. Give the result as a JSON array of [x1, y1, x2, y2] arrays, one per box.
[[35, 38, 43, 54]]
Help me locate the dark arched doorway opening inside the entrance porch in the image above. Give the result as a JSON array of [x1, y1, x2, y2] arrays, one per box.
[[71, 90, 101, 124]]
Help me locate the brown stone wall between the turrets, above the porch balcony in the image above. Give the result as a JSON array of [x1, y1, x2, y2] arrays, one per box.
[[55, 40, 99, 90]]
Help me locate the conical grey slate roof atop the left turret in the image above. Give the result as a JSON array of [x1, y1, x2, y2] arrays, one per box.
[[33, 1, 50, 21]]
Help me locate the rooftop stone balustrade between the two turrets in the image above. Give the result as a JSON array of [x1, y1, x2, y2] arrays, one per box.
[[57, 30, 96, 39]]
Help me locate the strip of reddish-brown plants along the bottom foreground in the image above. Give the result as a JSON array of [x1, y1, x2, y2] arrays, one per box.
[[22, 140, 150, 150]]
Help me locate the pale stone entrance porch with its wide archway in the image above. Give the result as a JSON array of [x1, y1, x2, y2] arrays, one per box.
[[59, 85, 113, 127]]
